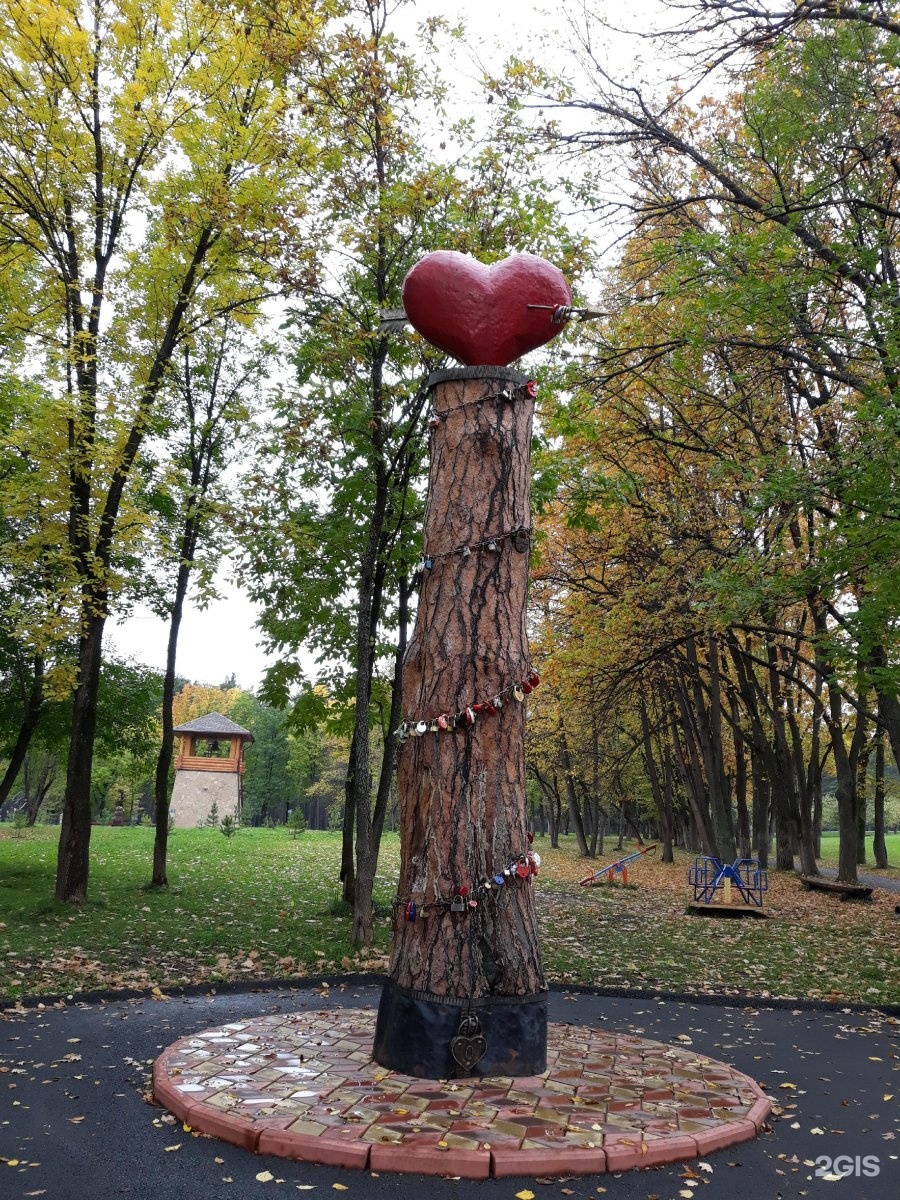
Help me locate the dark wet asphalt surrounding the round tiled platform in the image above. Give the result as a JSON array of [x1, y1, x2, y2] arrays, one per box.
[[0, 982, 900, 1200]]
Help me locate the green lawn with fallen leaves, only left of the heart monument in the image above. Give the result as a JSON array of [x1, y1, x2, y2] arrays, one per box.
[[0, 826, 398, 995]]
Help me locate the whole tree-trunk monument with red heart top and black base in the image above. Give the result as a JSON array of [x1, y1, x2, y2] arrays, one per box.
[[374, 251, 571, 1079]]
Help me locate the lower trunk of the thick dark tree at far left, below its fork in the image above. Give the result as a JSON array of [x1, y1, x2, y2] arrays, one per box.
[[55, 602, 106, 904]]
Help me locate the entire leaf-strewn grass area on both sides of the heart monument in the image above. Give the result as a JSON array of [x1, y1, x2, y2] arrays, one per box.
[[0, 827, 900, 1004]]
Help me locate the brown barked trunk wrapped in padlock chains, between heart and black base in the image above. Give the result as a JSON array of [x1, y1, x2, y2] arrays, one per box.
[[379, 367, 546, 1080]]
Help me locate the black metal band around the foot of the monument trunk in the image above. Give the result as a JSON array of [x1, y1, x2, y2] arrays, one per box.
[[372, 979, 547, 1079]]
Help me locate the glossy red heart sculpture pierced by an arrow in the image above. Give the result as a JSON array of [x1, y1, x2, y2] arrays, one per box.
[[403, 250, 572, 367]]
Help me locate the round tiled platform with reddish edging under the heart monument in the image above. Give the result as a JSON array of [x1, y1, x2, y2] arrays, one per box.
[[154, 1008, 772, 1178]]
